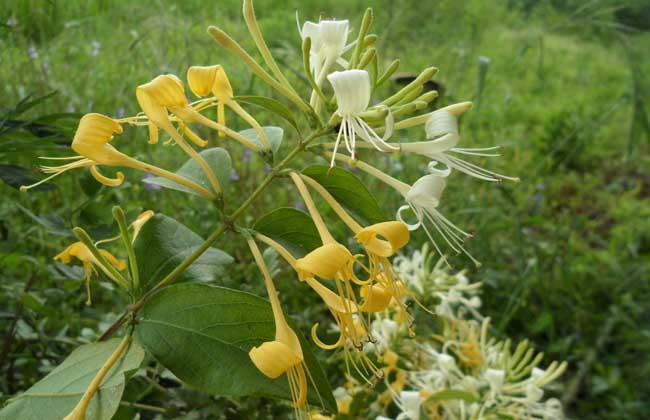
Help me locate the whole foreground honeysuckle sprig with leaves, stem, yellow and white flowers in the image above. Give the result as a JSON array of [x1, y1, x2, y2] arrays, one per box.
[[0, 0, 553, 420]]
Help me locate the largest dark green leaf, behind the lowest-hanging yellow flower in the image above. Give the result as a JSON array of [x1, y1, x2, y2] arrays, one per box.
[[136, 283, 336, 412]]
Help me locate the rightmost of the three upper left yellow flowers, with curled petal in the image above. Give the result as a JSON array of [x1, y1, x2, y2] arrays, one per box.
[[187, 65, 271, 149]]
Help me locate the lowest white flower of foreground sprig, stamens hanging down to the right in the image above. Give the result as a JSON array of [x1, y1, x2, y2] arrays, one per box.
[[397, 171, 480, 265]]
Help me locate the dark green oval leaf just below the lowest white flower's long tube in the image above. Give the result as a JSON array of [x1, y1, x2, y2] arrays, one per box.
[[302, 165, 386, 224]]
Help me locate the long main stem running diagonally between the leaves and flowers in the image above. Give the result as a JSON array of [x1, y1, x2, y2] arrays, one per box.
[[99, 126, 332, 341]]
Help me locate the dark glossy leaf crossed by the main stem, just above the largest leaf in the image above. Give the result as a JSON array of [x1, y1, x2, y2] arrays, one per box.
[[133, 214, 233, 290]]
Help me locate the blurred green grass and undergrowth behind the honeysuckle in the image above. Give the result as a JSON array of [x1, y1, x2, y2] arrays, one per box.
[[0, 0, 650, 419]]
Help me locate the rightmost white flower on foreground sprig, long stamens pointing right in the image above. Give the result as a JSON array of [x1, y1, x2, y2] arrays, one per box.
[[400, 102, 519, 182]]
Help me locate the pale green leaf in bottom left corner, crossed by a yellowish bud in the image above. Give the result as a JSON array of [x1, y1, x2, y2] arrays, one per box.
[[0, 339, 144, 420]]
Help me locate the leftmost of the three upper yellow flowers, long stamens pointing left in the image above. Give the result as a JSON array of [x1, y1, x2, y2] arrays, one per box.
[[20, 113, 214, 199]]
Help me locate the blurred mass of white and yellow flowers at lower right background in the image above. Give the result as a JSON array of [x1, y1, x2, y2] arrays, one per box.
[[317, 246, 567, 420]]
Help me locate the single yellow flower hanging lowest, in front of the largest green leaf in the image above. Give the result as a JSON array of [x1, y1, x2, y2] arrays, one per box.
[[247, 238, 311, 412]]
